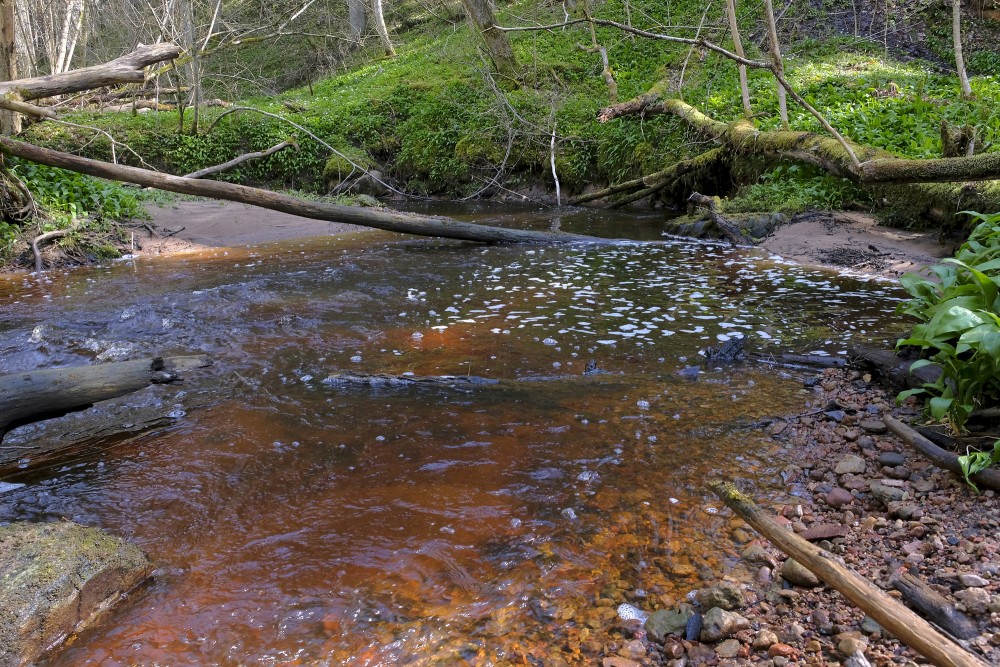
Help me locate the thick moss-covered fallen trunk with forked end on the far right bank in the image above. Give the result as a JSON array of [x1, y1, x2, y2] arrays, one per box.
[[591, 93, 1000, 223]]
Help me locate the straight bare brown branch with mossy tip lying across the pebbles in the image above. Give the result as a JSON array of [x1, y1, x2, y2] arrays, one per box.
[[710, 481, 986, 667]]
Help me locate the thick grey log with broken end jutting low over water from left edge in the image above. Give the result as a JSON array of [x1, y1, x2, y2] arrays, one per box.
[[0, 356, 212, 441]]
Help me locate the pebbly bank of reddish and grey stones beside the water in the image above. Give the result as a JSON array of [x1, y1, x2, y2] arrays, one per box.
[[603, 369, 1000, 667]]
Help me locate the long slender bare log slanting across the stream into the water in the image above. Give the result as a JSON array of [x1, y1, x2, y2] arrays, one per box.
[[0, 137, 610, 243]]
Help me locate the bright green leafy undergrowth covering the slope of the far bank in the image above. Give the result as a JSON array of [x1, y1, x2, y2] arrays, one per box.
[[19, 0, 1000, 215]]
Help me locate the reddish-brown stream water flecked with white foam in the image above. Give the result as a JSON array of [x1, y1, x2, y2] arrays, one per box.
[[0, 206, 901, 665]]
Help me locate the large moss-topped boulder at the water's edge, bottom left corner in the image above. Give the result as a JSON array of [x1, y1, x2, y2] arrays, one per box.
[[0, 522, 153, 667]]
